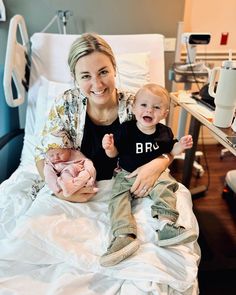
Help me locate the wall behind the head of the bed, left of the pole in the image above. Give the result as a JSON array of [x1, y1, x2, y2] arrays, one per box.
[[0, 0, 185, 91]]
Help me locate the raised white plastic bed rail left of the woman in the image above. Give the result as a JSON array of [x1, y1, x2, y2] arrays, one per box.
[[3, 15, 30, 107]]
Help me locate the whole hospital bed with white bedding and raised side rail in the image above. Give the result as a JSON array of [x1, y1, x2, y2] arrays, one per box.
[[0, 15, 200, 295]]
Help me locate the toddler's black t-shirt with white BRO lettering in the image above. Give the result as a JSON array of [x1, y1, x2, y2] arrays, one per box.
[[115, 120, 177, 172]]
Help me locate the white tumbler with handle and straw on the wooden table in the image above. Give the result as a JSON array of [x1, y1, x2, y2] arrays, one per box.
[[209, 56, 236, 128]]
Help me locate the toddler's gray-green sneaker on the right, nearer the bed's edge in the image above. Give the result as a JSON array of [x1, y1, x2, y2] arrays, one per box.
[[157, 223, 197, 247]]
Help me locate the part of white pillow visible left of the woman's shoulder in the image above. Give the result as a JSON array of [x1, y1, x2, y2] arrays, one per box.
[[34, 76, 73, 136]]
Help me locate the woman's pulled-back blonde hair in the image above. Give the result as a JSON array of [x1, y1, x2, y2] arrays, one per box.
[[68, 33, 116, 77]]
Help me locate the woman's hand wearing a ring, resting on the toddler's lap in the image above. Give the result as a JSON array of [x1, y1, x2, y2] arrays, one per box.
[[127, 156, 172, 198]]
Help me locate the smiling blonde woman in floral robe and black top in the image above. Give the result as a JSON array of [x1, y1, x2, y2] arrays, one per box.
[[36, 33, 171, 202]]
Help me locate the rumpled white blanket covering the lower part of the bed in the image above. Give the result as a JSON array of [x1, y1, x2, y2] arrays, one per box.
[[0, 165, 200, 295]]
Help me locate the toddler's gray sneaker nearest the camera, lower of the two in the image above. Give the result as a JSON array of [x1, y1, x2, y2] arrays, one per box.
[[100, 236, 139, 266]]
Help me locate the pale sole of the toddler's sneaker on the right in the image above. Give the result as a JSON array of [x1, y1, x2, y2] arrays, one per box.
[[157, 229, 197, 247]]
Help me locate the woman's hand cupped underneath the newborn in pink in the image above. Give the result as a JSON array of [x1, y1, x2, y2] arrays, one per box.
[[55, 186, 98, 203]]
